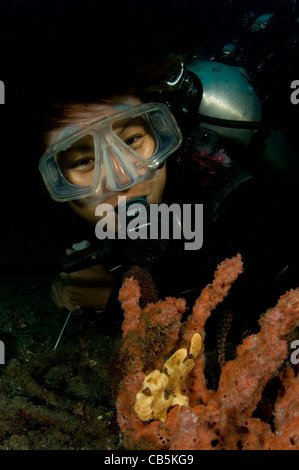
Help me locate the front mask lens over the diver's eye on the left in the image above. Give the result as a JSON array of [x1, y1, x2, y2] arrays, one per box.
[[56, 135, 95, 186]]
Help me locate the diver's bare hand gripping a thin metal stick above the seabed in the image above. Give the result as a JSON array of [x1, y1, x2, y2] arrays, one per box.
[[51, 265, 113, 312]]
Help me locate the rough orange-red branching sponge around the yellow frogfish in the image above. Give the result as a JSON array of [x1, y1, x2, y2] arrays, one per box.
[[116, 255, 299, 450]]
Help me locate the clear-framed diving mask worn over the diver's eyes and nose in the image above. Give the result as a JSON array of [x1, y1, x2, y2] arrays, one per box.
[[39, 103, 182, 204]]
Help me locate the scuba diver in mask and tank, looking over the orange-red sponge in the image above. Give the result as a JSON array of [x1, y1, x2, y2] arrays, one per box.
[[39, 0, 299, 338]]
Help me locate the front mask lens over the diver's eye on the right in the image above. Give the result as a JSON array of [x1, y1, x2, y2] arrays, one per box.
[[112, 116, 156, 158]]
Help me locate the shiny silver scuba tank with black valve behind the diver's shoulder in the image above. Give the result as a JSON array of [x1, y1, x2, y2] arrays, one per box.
[[168, 59, 299, 196]]
